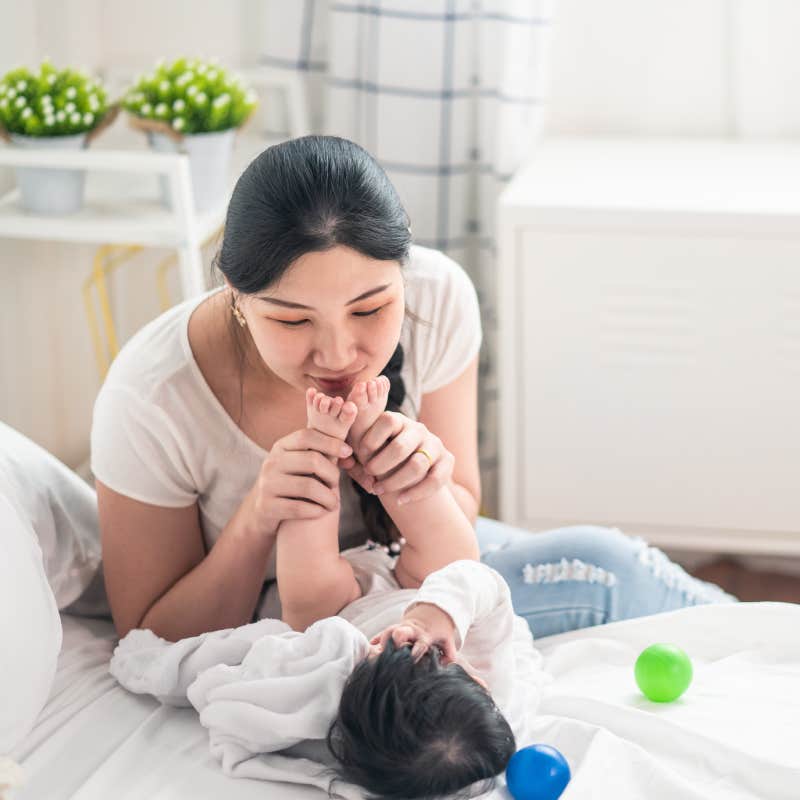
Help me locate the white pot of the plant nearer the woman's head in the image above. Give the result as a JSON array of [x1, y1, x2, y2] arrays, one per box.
[[147, 128, 236, 211]]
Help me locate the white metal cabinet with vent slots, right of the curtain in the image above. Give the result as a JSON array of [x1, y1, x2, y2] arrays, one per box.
[[498, 134, 800, 555]]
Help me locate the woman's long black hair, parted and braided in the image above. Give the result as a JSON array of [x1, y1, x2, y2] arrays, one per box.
[[212, 136, 428, 544]]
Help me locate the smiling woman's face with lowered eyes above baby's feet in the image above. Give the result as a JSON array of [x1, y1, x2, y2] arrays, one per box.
[[238, 241, 405, 397]]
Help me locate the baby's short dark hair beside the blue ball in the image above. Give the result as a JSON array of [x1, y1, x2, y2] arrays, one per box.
[[326, 639, 516, 800]]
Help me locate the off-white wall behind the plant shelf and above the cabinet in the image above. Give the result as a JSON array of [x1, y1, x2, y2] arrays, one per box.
[[0, 0, 800, 465]]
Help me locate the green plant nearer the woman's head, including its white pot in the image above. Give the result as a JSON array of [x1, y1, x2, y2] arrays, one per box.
[[122, 57, 257, 211]]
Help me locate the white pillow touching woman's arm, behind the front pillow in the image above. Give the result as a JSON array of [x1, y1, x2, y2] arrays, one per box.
[[0, 422, 101, 609]]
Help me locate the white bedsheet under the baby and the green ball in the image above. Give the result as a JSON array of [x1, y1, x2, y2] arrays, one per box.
[[11, 603, 800, 800]]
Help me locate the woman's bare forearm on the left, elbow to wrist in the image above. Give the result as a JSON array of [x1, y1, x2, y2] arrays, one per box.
[[142, 495, 275, 642]]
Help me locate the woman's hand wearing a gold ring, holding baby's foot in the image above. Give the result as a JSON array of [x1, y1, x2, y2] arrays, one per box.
[[338, 411, 455, 503]]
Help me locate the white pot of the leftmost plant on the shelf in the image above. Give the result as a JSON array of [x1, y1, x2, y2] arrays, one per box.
[[11, 133, 87, 214]]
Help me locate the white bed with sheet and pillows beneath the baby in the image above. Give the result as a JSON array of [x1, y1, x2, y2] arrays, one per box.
[[0, 423, 800, 800]]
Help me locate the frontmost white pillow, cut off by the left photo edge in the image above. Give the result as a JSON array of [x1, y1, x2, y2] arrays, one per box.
[[0, 495, 62, 755]]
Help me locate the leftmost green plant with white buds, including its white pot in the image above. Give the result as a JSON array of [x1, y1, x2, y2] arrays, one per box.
[[0, 59, 119, 214]]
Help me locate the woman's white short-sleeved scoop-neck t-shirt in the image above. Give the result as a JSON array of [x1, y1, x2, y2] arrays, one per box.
[[91, 245, 482, 600]]
